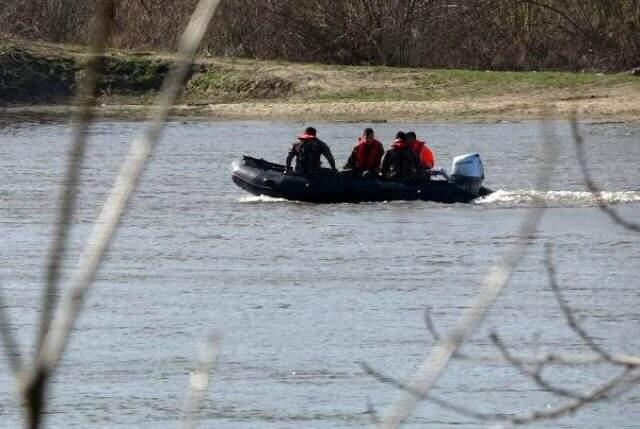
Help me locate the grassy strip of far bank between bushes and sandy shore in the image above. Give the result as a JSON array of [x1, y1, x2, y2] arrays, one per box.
[[0, 37, 640, 107]]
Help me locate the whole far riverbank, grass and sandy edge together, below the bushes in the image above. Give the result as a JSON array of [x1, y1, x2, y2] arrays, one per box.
[[0, 40, 640, 121]]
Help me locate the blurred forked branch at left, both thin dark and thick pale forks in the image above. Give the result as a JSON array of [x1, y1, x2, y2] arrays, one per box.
[[12, 0, 219, 428]]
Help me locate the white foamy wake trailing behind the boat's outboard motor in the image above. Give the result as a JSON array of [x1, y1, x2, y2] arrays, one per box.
[[475, 189, 640, 207]]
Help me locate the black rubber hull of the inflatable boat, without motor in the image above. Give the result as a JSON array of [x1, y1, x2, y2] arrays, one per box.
[[232, 156, 492, 203]]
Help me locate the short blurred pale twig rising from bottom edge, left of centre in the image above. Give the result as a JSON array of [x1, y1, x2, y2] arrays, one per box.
[[183, 335, 218, 429]]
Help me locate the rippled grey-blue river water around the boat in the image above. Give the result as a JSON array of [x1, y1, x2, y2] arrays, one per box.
[[0, 121, 640, 428]]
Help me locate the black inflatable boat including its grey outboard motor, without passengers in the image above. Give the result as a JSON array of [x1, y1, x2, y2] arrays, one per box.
[[232, 154, 493, 203]]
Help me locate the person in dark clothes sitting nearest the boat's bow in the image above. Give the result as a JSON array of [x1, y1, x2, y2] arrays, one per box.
[[285, 127, 337, 175]]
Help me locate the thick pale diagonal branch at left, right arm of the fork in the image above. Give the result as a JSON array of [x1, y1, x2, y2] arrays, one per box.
[[25, 0, 219, 428]]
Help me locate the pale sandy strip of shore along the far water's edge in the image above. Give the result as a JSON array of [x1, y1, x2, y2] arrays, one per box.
[[0, 100, 640, 123]]
